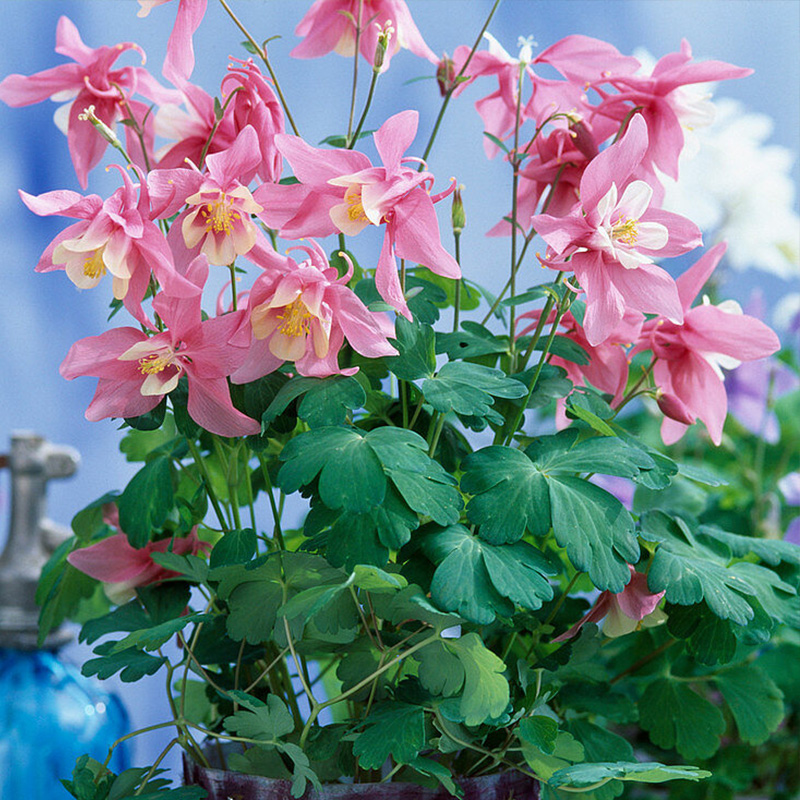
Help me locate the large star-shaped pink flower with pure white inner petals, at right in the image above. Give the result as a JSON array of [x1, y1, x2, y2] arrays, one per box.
[[531, 115, 702, 345]]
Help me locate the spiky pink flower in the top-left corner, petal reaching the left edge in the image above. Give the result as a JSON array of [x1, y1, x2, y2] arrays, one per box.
[[0, 17, 175, 189]]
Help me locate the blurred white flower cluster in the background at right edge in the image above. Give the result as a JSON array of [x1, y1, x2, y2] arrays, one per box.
[[663, 98, 800, 280]]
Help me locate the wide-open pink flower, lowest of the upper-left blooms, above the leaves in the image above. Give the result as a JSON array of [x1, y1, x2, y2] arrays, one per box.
[[61, 256, 261, 436]]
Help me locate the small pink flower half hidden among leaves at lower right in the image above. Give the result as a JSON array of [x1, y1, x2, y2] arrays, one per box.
[[553, 564, 667, 642]]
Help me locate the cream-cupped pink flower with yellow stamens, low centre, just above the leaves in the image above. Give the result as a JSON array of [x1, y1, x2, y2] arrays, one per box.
[[231, 241, 397, 383]]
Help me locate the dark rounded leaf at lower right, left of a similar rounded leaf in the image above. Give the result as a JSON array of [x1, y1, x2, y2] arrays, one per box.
[[639, 678, 725, 759]]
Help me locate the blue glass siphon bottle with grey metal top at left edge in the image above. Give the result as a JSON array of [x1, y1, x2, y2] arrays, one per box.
[[0, 433, 130, 800]]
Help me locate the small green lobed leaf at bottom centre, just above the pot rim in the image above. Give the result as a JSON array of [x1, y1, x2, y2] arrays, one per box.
[[353, 702, 426, 769]]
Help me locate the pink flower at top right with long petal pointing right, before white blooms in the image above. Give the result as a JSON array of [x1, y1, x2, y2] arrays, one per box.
[[594, 39, 753, 180]]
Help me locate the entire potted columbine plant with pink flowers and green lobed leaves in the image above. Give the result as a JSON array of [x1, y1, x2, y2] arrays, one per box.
[[0, 0, 800, 800]]
